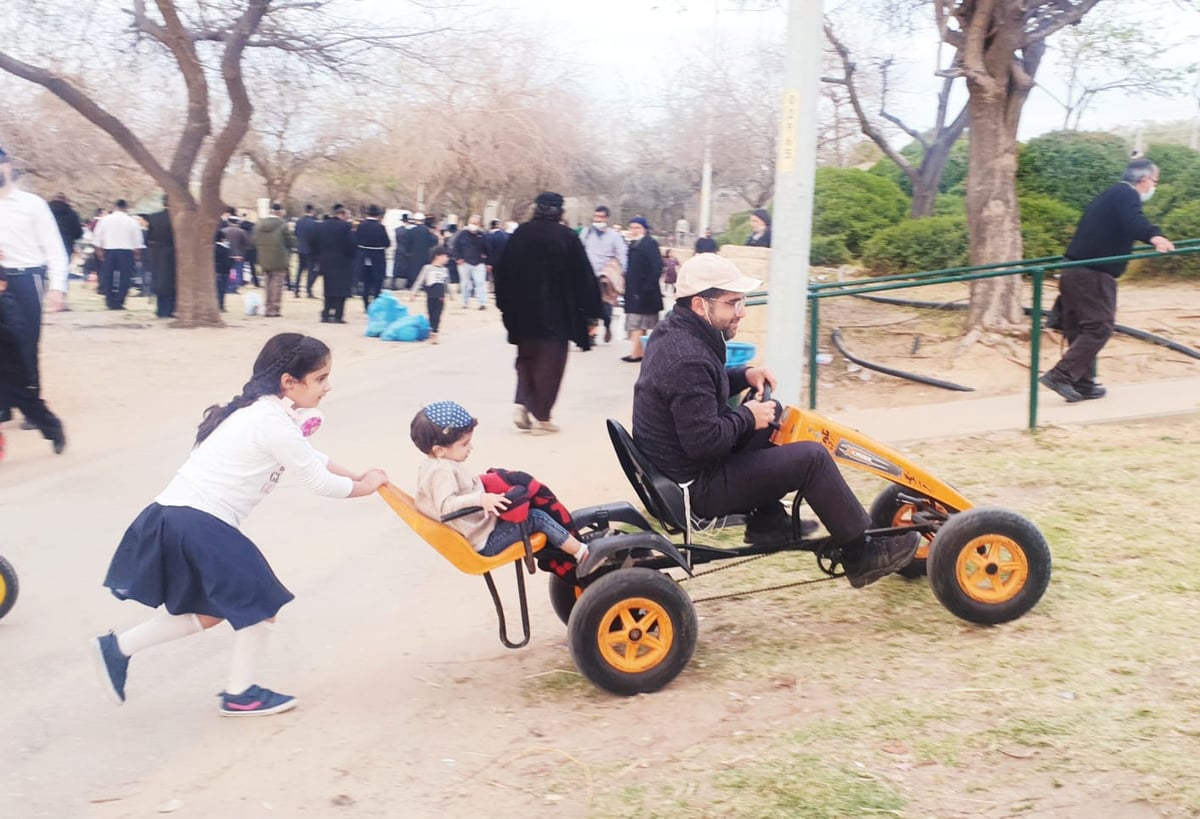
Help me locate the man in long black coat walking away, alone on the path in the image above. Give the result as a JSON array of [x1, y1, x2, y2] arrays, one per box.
[[493, 191, 604, 435]]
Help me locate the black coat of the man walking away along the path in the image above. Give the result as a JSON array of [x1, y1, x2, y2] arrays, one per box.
[[492, 219, 604, 349]]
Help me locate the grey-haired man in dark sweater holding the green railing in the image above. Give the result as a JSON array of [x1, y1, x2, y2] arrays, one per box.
[[1040, 157, 1175, 403]]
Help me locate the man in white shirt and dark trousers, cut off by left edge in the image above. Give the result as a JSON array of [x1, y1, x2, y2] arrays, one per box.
[[0, 148, 67, 437]]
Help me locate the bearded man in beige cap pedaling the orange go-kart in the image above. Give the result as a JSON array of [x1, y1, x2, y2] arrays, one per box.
[[634, 253, 920, 588]]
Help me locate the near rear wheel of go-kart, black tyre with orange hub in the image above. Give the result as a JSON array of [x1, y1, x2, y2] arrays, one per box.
[[566, 568, 696, 697]]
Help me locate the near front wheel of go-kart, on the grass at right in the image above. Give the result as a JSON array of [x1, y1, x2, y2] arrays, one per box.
[[928, 507, 1050, 626]]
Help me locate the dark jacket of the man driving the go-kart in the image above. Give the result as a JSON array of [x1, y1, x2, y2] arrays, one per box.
[[634, 304, 755, 483]]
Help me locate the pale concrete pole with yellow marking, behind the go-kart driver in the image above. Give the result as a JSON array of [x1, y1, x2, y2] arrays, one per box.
[[766, 0, 823, 406]]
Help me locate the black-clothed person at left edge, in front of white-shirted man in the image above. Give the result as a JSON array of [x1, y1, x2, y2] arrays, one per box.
[[0, 269, 67, 458]]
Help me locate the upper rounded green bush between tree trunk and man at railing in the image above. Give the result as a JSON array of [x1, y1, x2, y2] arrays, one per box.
[[1016, 131, 1129, 210]]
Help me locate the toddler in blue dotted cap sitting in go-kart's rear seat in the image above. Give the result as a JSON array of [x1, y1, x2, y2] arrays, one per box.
[[410, 401, 588, 564]]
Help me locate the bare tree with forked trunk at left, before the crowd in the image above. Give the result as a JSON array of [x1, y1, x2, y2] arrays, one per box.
[[0, 0, 446, 327]]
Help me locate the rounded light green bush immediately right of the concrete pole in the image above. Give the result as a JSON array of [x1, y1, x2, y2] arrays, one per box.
[[812, 168, 908, 255]]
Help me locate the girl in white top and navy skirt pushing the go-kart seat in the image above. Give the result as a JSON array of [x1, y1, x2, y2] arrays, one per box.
[[92, 333, 388, 717]]
